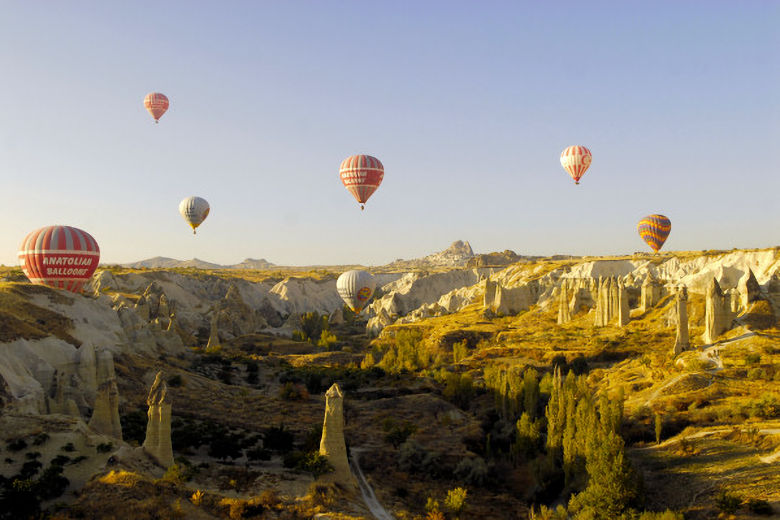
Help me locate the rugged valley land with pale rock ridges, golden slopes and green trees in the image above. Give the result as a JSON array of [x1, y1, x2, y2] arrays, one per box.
[[0, 248, 780, 519]]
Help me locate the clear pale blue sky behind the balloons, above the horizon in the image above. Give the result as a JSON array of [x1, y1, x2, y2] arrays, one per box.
[[0, 0, 780, 265]]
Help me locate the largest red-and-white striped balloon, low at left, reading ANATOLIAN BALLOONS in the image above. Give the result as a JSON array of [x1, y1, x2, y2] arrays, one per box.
[[18, 226, 100, 293]]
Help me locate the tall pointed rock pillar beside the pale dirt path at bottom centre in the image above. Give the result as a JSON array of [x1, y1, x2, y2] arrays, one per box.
[[320, 383, 357, 489]]
